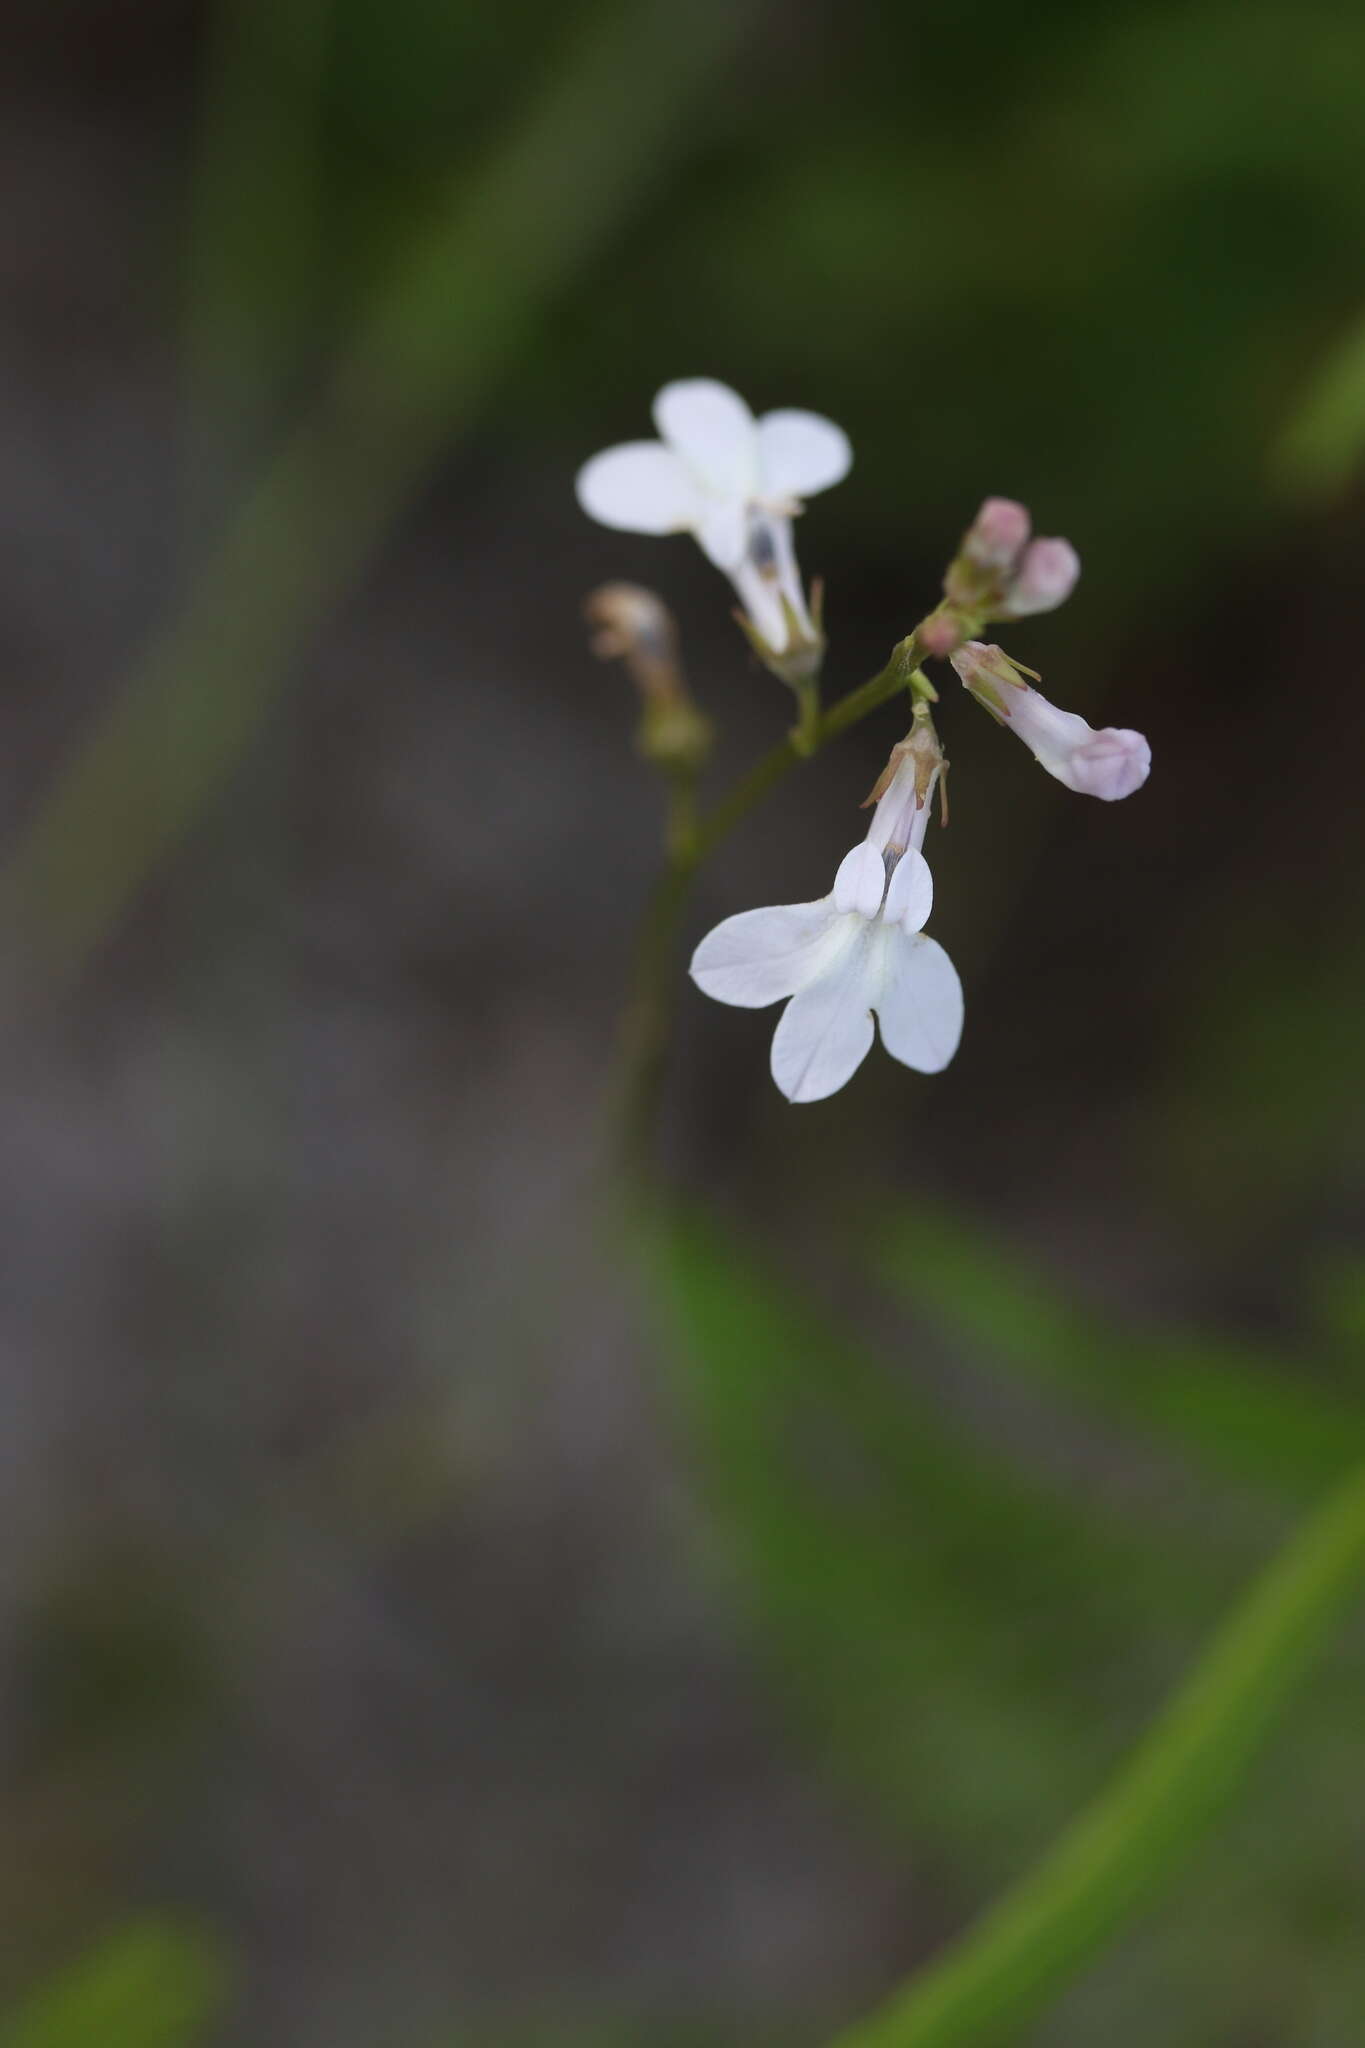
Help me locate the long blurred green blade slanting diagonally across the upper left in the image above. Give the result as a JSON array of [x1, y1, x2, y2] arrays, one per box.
[[4, 0, 757, 977]]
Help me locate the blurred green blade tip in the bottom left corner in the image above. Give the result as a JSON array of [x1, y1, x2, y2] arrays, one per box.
[[0, 1919, 229, 2048]]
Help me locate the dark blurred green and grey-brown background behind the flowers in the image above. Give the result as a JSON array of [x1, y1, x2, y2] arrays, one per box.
[[0, 0, 1365, 2048]]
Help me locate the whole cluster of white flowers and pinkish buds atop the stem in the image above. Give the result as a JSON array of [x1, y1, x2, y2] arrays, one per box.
[[577, 377, 1152, 1102]]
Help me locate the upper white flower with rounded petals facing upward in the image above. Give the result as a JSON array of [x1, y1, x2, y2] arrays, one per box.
[[577, 377, 853, 653]]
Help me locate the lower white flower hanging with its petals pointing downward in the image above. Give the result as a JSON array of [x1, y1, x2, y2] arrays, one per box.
[[692, 760, 962, 1102]]
